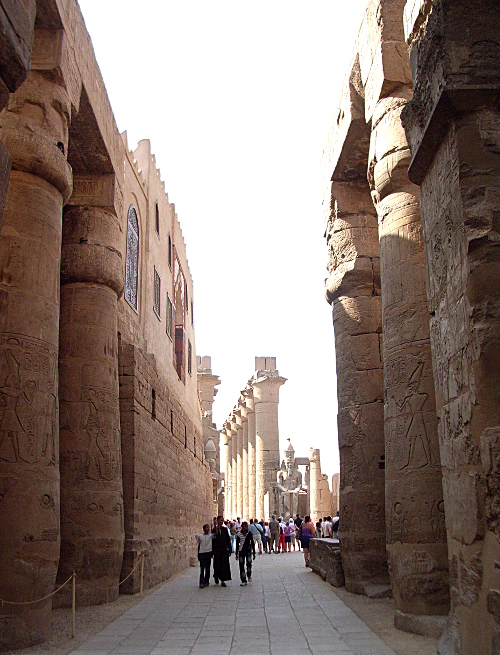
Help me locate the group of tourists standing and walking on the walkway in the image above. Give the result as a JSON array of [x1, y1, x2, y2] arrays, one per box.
[[198, 512, 339, 588]]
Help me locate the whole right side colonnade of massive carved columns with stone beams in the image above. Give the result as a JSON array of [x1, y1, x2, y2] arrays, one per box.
[[323, 0, 500, 655]]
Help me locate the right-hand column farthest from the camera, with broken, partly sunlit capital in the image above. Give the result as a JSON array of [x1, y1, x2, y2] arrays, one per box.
[[324, 178, 389, 593]]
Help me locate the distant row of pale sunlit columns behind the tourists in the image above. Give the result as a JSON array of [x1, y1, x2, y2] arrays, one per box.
[[223, 370, 285, 519]]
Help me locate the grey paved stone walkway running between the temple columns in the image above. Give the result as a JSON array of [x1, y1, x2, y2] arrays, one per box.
[[67, 552, 395, 655]]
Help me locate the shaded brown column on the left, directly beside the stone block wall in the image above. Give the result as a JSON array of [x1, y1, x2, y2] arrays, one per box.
[[58, 175, 125, 604]]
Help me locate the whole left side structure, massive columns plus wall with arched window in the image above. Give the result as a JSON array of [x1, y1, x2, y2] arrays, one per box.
[[0, 0, 213, 649]]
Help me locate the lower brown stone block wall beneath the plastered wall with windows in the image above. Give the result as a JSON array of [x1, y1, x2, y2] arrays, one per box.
[[119, 342, 212, 593]]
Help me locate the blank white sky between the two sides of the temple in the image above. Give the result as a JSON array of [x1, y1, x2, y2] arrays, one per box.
[[80, 0, 366, 476]]
